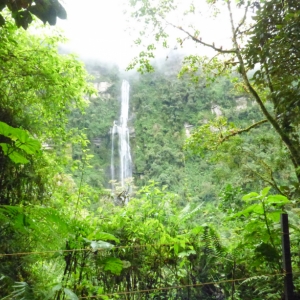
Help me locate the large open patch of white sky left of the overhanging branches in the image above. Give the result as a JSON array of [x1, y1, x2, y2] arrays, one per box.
[[58, 0, 137, 65]]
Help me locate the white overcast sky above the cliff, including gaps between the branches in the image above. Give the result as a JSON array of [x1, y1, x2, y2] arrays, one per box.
[[58, 0, 240, 69]]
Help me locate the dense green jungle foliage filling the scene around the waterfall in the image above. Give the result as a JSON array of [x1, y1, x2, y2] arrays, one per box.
[[0, 0, 300, 300]]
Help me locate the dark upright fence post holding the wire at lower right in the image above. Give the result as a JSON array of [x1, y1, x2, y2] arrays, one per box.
[[280, 214, 294, 300]]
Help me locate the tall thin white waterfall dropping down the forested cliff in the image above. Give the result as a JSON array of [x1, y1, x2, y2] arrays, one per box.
[[111, 80, 132, 187]]
